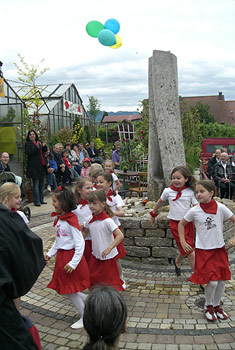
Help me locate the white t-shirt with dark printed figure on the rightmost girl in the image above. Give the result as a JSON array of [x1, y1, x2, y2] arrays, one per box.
[[184, 202, 233, 249]]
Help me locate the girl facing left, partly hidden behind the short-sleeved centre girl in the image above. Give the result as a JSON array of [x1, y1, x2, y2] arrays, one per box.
[[97, 173, 126, 287]]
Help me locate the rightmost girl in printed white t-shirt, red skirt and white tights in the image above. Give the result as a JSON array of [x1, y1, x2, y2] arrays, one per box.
[[179, 180, 235, 321]]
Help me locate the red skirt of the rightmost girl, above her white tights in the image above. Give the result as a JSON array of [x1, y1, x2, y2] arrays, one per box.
[[189, 246, 231, 284]]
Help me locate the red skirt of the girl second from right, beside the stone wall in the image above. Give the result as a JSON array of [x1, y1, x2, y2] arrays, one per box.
[[170, 219, 195, 255]]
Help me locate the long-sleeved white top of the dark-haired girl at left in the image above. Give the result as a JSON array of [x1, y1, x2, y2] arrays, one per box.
[[47, 220, 85, 270]]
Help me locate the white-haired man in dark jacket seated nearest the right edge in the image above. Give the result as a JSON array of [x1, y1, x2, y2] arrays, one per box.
[[213, 152, 235, 199]]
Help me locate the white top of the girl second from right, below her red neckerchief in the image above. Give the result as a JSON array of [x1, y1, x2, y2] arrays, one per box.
[[160, 187, 198, 220]]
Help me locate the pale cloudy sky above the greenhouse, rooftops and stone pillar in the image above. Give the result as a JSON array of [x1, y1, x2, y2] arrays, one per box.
[[0, 0, 235, 112]]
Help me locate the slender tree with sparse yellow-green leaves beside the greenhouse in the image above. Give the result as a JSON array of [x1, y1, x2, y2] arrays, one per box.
[[14, 53, 49, 137]]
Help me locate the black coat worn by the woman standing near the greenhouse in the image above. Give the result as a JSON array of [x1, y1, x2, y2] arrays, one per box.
[[25, 140, 47, 179]]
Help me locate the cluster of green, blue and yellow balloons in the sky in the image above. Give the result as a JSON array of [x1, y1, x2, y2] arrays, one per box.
[[86, 18, 122, 49]]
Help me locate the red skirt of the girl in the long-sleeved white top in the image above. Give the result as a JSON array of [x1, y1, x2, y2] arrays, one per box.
[[47, 249, 90, 294]]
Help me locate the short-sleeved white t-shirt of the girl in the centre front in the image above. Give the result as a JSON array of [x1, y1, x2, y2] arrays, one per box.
[[85, 218, 118, 260]]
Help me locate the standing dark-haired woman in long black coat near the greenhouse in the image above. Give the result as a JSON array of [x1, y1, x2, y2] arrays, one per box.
[[25, 130, 47, 207]]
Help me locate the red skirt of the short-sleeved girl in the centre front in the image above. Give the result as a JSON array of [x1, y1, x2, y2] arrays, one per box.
[[89, 255, 124, 291]]
